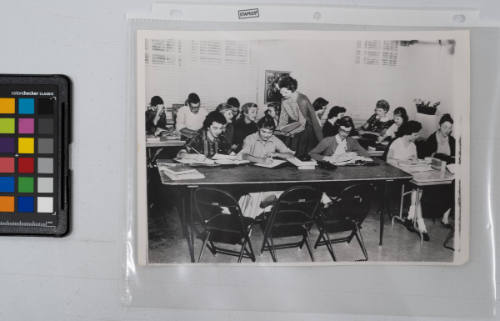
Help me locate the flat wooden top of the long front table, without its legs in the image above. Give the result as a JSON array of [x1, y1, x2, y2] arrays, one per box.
[[158, 160, 412, 186]]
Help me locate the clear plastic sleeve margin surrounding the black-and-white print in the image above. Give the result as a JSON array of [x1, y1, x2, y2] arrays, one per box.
[[123, 4, 500, 317]]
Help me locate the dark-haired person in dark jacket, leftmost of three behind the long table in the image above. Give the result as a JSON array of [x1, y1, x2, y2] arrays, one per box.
[[177, 111, 229, 158]]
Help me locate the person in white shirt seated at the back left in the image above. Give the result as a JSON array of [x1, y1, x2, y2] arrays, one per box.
[[175, 93, 208, 139]]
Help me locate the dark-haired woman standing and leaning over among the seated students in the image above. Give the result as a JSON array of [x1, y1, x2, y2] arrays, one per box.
[[277, 76, 323, 158]]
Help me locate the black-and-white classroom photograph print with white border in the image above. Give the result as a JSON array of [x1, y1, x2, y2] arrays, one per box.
[[136, 30, 469, 265]]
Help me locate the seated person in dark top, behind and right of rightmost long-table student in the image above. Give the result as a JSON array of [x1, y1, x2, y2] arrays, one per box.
[[359, 99, 394, 147]]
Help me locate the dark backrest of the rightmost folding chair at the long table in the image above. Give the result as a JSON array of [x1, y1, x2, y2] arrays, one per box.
[[332, 184, 374, 224]]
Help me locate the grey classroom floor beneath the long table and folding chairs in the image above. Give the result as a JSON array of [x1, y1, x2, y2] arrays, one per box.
[[149, 192, 454, 263]]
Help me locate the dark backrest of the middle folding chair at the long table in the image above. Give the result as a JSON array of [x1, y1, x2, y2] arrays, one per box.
[[267, 186, 321, 226]]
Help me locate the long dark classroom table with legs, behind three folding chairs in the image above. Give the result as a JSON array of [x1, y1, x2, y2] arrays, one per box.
[[160, 160, 412, 262]]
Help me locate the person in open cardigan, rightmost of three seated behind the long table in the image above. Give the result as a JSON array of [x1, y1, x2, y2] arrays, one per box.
[[309, 116, 370, 163]]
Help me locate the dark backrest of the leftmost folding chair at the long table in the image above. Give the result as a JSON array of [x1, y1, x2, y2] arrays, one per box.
[[194, 187, 245, 231]]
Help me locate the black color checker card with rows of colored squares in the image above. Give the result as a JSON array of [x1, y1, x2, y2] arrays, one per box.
[[0, 75, 71, 236]]
